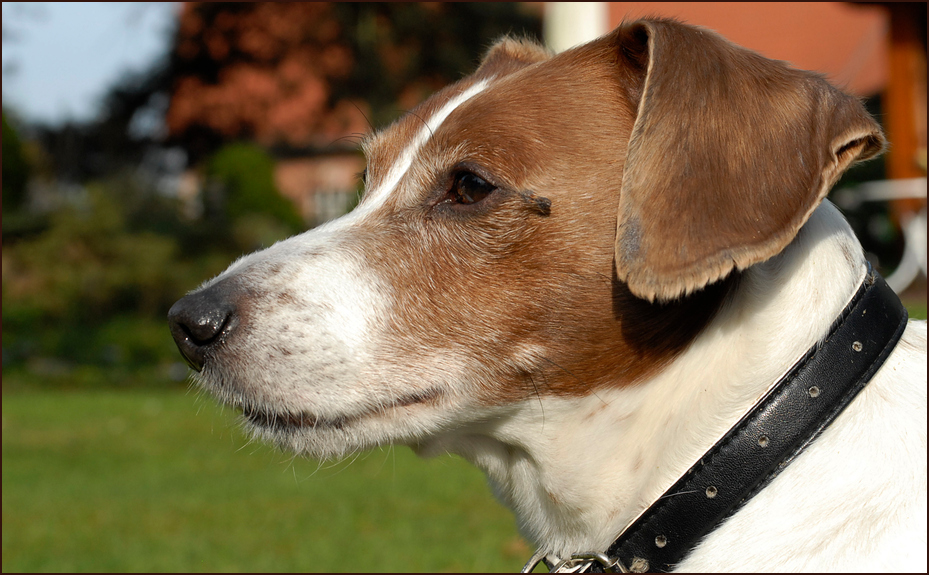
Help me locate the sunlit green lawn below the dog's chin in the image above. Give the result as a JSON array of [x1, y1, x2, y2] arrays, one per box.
[[2, 389, 531, 572]]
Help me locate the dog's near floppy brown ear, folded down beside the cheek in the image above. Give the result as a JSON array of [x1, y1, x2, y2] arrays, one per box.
[[613, 20, 884, 301]]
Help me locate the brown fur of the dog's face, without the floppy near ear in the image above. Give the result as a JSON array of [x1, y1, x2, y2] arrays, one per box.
[[357, 31, 728, 403]]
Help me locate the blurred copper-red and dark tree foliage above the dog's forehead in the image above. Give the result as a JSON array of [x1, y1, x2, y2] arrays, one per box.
[[167, 2, 541, 161]]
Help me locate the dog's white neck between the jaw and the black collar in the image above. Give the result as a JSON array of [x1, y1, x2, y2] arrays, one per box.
[[419, 203, 865, 555]]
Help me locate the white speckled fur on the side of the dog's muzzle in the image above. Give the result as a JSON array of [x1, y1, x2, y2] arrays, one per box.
[[201, 225, 387, 418]]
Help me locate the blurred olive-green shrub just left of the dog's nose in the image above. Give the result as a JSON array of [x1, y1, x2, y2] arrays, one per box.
[[2, 184, 192, 375]]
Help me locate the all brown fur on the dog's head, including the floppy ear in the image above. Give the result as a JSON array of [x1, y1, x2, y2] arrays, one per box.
[[348, 21, 883, 403]]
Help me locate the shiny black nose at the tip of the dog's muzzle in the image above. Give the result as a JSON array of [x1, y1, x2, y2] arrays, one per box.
[[168, 282, 238, 371]]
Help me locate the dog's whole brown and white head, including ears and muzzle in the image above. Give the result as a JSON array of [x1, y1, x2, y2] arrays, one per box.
[[170, 16, 883, 456]]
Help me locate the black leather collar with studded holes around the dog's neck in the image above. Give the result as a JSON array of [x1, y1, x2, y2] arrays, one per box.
[[527, 266, 907, 573]]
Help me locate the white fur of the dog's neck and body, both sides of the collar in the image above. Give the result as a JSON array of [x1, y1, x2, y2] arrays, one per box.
[[423, 203, 926, 571]]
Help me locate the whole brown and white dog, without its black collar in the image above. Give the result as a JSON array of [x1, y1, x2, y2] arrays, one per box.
[[169, 19, 927, 571]]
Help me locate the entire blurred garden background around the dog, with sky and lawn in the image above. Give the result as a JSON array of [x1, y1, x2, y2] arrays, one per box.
[[2, 2, 926, 571]]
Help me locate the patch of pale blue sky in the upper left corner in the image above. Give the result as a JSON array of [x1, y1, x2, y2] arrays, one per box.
[[3, 2, 180, 123]]
